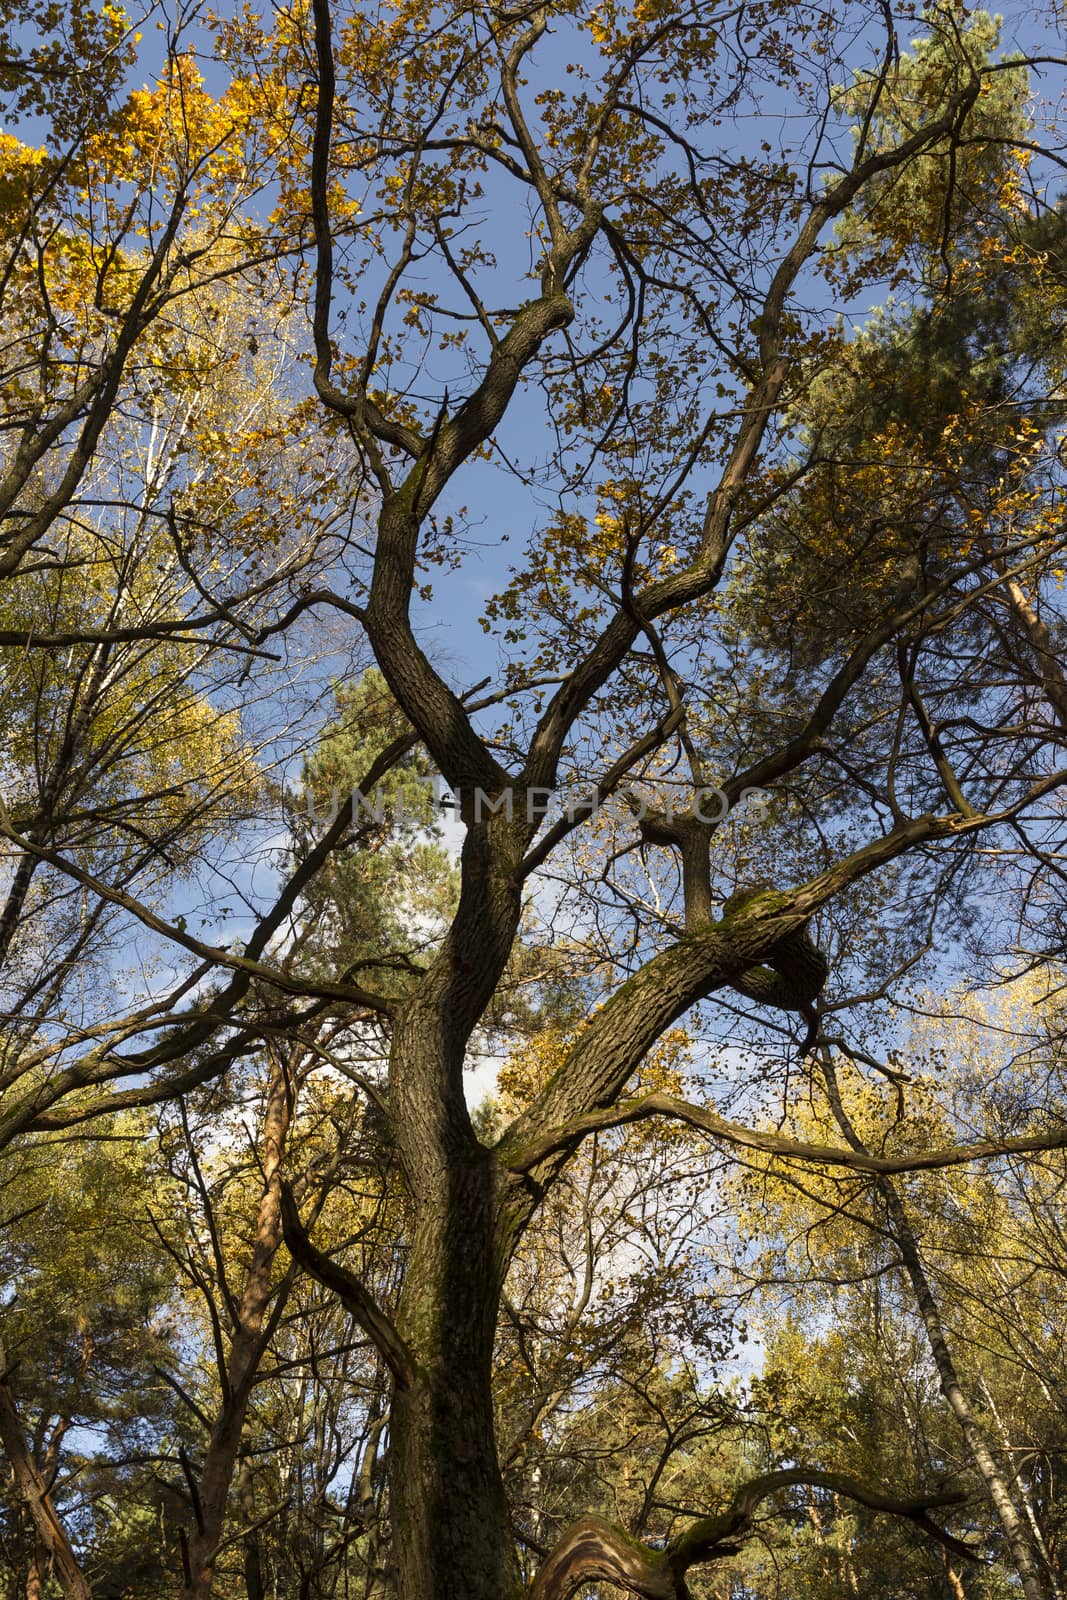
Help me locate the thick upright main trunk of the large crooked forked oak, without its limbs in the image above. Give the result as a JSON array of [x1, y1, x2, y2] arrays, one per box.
[[389, 818, 523, 1600]]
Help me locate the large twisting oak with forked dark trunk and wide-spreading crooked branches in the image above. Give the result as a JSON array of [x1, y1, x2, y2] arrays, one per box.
[[0, 0, 1067, 1600]]
